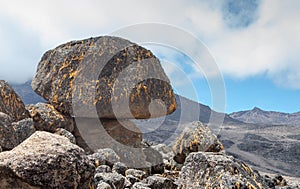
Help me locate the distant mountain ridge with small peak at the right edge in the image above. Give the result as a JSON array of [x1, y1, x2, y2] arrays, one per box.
[[229, 107, 300, 126]]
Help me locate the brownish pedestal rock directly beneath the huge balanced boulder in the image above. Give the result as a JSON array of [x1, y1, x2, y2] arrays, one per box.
[[74, 118, 148, 167]]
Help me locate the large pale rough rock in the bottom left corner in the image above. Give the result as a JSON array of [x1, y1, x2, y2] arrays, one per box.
[[0, 131, 95, 188]]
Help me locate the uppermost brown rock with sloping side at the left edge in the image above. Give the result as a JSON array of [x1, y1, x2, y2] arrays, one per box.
[[0, 80, 29, 121]]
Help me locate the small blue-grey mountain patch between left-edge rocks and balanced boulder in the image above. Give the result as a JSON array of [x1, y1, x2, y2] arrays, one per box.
[[11, 80, 45, 105]]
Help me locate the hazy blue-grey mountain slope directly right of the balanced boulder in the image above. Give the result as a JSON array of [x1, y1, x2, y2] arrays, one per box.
[[133, 95, 244, 144]]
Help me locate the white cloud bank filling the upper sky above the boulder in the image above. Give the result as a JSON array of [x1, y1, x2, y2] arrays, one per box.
[[0, 0, 300, 89]]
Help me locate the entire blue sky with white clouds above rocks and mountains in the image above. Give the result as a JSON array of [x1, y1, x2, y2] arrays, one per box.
[[0, 0, 300, 113]]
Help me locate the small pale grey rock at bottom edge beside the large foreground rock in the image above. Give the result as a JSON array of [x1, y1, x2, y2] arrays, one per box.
[[94, 173, 125, 189]]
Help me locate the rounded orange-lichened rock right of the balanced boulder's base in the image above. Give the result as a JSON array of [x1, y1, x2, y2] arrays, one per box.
[[173, 121, 224, 164]]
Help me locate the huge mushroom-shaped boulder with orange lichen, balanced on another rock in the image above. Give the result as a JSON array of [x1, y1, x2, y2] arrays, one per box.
[[32, 36, 176, 119]]
